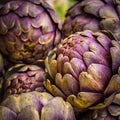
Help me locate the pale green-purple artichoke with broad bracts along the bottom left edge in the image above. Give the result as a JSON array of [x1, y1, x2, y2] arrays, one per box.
[[0, 92, 75, 120]]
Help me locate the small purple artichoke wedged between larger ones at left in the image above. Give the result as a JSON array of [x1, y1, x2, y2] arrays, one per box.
[[4, 62, 45, 98]]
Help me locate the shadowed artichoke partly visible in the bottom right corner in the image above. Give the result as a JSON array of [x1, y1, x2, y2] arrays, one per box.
[[77, 93, 120, 120]]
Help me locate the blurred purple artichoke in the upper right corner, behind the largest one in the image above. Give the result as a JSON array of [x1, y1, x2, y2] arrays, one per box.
[[62, 0, 120, 40]]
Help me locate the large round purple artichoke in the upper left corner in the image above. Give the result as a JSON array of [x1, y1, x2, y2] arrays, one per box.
[[0, 0, 61, 63]]
